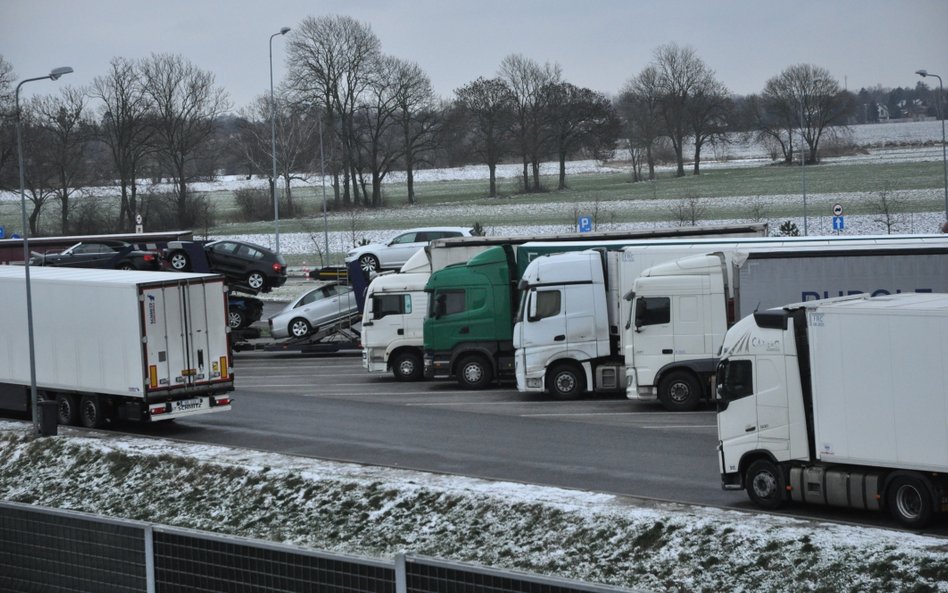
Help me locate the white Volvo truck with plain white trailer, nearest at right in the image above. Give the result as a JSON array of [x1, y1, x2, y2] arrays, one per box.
[[717, 294, 948, 528]]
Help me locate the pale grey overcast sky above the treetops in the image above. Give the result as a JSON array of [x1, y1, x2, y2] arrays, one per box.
[[0, 0, 948, 108]]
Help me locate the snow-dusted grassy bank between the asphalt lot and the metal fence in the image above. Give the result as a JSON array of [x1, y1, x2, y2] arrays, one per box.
[[0, 421, 948, 593]]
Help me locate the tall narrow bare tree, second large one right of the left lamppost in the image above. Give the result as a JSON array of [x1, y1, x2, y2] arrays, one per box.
[[89, 58, 154, 231]]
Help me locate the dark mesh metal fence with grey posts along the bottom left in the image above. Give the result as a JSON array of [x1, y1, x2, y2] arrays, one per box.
[[0, 502, 629, 593]]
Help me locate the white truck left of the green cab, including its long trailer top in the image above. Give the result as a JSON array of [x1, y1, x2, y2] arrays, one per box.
[[361, 224, 767, 381]]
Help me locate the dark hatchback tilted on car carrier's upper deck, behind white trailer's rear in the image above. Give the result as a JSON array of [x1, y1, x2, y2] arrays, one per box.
[[164, 239, 286, 293]]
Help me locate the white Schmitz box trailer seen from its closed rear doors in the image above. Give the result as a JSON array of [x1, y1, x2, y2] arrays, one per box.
[[0, 266, 234, 428]]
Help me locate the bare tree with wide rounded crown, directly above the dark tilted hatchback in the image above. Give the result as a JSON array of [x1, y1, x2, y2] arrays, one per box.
[[142, 54, 229, 226]]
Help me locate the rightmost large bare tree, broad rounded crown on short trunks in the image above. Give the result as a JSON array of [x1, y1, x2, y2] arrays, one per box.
[[762, 64, 855, 163]]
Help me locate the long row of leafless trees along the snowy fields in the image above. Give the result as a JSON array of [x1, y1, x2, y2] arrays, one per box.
[[0, 16, 920, 233]]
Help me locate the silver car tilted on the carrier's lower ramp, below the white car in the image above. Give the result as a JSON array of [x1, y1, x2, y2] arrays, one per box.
[[269, 282, 359, 338]]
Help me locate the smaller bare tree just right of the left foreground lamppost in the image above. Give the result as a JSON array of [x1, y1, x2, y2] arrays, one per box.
[[33, 86, 92, 235]]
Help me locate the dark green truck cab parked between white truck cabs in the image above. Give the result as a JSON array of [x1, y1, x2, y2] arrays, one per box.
[[424, 245, 519, 389]]
